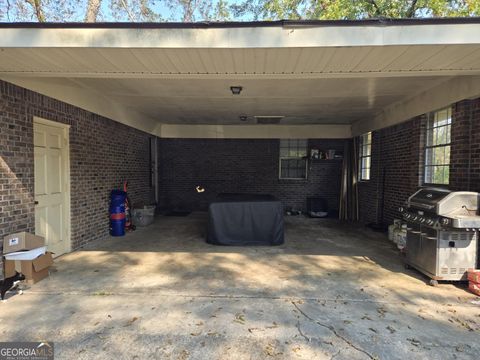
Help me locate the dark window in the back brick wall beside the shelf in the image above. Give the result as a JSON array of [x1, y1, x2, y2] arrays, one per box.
[[279, 140, 307, 179]]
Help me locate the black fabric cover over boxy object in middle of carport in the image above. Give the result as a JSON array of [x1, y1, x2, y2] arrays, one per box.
[[207, 194, 284, 246]]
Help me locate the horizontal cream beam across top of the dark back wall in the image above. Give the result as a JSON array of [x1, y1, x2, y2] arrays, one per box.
[[156, 124, 352, 139]]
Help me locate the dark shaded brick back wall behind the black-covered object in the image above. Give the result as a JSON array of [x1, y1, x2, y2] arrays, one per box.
[[159, 139, 344, 210]]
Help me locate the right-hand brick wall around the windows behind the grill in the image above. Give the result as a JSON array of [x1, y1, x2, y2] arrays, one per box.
[[359, 99, 480, 224]]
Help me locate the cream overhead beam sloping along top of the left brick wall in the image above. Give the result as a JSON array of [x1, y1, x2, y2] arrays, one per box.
[[1, 77, 158, 134]]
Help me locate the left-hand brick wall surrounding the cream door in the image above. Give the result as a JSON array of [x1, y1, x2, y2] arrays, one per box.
[[0, 81, 152, 278]]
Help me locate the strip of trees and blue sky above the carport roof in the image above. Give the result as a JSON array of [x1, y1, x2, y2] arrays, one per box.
[[0, 0, 480, 22]]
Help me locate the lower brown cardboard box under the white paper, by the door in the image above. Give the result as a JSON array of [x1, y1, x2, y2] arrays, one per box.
[[5, 252, 53, 284]]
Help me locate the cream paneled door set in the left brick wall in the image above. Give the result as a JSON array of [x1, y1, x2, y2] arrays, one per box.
[[33, 118, 70, 256]]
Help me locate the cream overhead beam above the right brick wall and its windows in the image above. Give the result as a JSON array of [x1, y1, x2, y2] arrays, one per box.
[[352, 76, 480, 136]]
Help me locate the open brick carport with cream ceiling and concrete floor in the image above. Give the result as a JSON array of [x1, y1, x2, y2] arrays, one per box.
[[0, 18, 480, 359]]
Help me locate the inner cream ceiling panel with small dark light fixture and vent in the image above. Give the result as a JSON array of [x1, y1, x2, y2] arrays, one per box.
[[64, 77, 449, 124]]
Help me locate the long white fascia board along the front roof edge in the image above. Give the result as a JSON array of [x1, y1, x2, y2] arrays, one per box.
[[0, 24, 480, 48]]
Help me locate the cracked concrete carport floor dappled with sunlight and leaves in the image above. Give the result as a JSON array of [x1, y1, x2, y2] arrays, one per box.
[[0, 213, 480, 360]]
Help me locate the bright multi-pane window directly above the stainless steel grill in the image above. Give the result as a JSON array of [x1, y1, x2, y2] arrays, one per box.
[[424, 107, 452, 184]]
